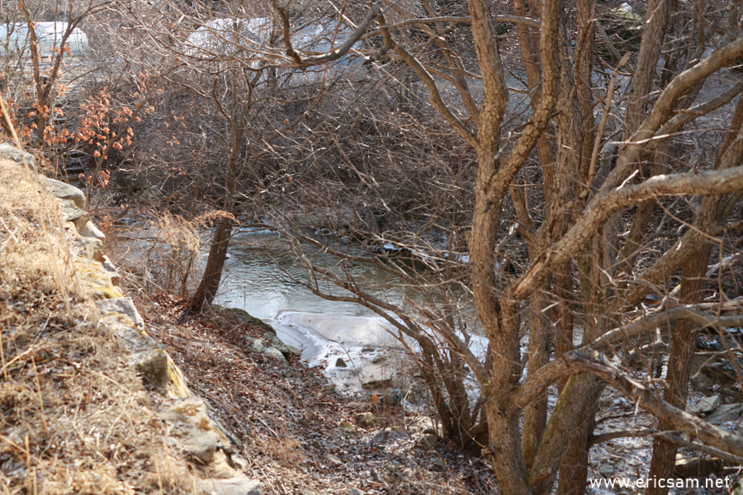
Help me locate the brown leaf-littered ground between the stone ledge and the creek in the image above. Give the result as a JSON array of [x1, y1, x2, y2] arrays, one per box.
[[137, 294, 499, 495]]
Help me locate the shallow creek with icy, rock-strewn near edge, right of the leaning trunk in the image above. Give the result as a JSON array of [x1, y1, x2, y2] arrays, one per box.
[[215, 230, 424, 391]]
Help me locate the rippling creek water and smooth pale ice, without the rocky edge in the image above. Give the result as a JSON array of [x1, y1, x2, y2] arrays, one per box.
[[215, 231, 418, 361]]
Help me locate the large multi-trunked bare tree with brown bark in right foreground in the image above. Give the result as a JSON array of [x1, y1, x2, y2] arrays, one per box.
[[254, 1, 743, 493]]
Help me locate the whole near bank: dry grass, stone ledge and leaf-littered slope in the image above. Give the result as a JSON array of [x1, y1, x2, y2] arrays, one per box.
[[0, 148, 496, 495]]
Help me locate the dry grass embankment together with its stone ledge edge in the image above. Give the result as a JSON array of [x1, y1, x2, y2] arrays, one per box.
[[0, 150, 260, 495]]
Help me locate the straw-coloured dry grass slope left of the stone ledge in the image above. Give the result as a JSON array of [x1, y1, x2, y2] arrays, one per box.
[[0, 161, 198, 494]]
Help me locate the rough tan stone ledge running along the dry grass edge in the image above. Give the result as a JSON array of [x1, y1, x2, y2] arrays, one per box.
[[35, 153, 262, 495]]
